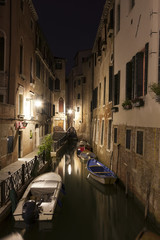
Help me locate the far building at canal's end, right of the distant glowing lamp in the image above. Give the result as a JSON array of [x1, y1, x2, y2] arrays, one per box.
[[67, 50, 92, 142]]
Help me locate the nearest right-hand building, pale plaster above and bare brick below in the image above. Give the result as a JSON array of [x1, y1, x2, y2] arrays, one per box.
[[113, 0, 160, 225]]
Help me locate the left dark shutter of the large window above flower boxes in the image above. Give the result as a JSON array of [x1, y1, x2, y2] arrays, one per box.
[[126, 62, 132, 99]]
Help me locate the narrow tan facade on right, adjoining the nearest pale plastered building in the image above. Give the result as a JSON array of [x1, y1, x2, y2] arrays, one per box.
[[92, 1, 114, 166]]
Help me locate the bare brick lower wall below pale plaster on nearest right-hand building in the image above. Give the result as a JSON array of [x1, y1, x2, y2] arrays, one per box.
[[112, 125, 160, 229]]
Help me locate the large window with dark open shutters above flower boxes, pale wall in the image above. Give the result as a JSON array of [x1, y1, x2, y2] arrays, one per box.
[[126, 43, 149, 99]]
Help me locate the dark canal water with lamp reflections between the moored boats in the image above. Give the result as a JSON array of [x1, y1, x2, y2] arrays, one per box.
[[0, 142, 158, 240]]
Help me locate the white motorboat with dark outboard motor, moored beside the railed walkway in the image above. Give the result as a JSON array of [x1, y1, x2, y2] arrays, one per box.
[[13, 172, 62, 224]]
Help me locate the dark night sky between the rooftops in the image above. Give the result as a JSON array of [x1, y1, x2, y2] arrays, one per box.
[[33, 0, 105, 72]]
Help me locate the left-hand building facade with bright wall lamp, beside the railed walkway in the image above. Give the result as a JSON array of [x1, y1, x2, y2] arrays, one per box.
[[0, 0, 65, 168]]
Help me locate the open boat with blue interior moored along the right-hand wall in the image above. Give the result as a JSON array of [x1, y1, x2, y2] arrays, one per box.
[[87, 159, 117, 184]]
